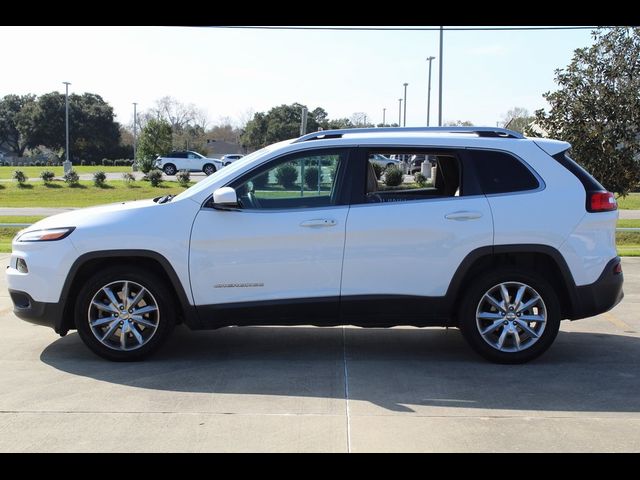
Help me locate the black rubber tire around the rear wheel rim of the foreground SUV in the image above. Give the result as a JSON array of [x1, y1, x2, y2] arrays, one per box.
[[458, 268, 560, 364]]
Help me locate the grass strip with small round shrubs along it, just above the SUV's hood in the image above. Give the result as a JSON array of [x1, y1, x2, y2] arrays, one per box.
[[0, 180, 185, 207]]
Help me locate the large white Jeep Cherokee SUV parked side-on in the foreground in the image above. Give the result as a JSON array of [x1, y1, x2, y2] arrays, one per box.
[[7, 127, 623, 363]]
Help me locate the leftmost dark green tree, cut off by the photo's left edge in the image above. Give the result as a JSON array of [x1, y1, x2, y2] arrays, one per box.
[[0, 95, 36, 157]]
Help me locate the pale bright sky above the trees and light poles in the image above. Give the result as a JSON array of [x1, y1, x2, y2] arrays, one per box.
[[0, 26, 593, 126]]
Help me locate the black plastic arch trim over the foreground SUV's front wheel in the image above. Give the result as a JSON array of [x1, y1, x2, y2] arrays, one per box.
[[56, 249, 200, 332]]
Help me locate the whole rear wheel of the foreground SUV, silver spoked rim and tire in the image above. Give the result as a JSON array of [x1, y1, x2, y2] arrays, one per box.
[[459, 269, 560, 363]]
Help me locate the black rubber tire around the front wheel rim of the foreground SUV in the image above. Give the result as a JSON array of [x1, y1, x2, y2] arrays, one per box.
[[74, 265, 176, 362]]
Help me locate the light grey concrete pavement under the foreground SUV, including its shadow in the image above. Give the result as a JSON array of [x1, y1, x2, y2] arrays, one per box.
[[0, 254, 640, 452]]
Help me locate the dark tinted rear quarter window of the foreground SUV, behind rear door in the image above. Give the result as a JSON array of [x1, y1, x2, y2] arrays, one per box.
[[469, 150, 540, 195]]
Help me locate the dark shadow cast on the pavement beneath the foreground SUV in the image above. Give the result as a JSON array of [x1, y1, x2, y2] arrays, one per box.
[[40, 327, 640, 412]]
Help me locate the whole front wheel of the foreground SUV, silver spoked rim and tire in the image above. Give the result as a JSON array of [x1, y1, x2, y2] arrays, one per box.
[[75, 266, 176, 361]]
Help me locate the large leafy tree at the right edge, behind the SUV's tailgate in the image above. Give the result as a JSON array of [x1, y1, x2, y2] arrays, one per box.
[[535, 27, 640, 196]]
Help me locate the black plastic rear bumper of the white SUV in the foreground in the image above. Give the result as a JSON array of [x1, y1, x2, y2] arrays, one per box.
[[571, 257, 624, 320]]
